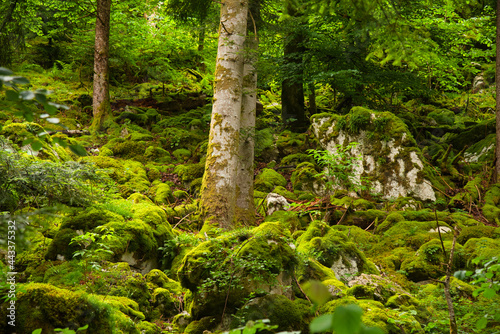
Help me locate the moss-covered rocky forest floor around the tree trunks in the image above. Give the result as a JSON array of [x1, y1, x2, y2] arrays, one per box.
[[0, 66, 500, 334]]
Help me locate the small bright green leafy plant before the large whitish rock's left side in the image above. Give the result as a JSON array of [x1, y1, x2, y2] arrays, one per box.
[[307, 142, 369, 192]]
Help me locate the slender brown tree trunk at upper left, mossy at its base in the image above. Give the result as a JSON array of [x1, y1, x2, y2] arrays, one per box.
[[91, 0, 111, 131]]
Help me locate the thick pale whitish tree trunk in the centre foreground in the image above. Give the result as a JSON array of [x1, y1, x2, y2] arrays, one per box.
[[200, 0, 248, 229]]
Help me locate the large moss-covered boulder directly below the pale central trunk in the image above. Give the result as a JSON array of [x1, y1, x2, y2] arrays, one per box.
[[177, 222, 296, 319]]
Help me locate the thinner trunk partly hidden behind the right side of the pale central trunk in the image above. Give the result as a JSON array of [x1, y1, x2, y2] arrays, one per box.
[[235, 34, 259, 226]]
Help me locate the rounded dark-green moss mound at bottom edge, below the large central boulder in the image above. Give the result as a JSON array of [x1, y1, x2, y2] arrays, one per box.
[[230, 295, 309, 331]]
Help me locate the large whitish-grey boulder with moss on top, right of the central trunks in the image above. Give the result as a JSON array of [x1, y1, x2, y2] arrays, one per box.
[[312, 107, 441, 201]]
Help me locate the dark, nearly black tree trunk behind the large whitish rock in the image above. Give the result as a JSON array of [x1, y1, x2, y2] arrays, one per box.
[[281, 5, 309, 131]]
